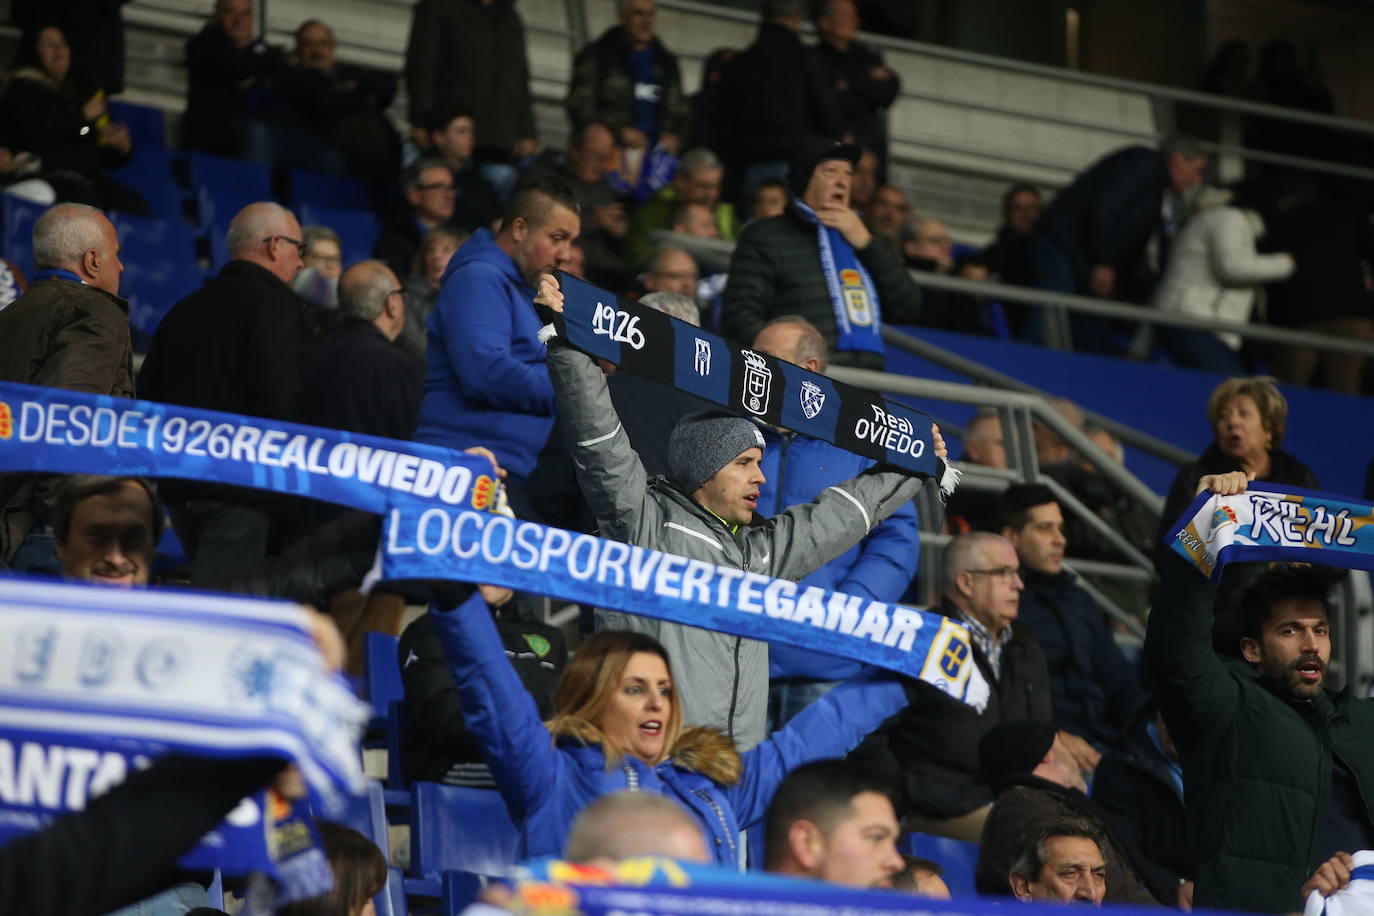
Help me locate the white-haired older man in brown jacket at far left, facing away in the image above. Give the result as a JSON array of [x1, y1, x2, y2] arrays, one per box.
[[0, 203, 133, 573]]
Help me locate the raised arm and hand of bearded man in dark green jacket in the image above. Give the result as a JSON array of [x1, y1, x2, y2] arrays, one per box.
[[1145, 471, 1245, 750]]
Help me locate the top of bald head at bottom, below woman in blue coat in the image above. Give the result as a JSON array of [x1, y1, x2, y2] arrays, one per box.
[[563, 792, 710, 864]]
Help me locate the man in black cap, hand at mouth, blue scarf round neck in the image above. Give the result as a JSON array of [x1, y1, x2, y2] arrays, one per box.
[[721, 137, 921, 369]]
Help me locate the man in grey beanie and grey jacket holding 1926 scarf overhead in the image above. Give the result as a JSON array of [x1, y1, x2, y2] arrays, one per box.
[[536, 276, 947, 751]]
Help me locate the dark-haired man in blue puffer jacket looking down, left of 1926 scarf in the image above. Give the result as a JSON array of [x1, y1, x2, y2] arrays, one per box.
[[415, 179, 580, 516]]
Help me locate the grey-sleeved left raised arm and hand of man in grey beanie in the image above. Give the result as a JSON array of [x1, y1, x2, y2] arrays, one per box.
[[536, 276, 658, 542]]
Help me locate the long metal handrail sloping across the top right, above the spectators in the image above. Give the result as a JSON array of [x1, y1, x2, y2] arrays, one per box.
[[658, 0, 1374, 135]]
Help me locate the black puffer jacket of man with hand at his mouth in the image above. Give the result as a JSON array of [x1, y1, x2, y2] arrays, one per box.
[[720, 203, 921, 369]]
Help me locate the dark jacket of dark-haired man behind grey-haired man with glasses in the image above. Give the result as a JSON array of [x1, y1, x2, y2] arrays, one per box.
[[1017, 569, 1145, 744]]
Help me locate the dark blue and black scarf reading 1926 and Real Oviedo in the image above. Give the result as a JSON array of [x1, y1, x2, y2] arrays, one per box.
[[555, 271, 952, 488]]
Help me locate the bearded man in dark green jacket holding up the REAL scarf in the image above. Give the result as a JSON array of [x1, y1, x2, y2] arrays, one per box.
[[1145, 471, 1374, 913]]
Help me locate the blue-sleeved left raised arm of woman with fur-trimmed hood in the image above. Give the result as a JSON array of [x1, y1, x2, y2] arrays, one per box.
[[431, 591, 563, 824]]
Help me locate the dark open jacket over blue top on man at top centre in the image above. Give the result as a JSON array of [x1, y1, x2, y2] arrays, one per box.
[[567, 26, 690, 136]]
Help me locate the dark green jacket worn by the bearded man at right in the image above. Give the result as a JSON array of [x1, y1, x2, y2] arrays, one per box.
[[1145, 556, 1374, 913]]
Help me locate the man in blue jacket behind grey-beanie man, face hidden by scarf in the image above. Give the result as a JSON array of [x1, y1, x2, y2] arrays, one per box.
[[753, 314, 921, 731]]
